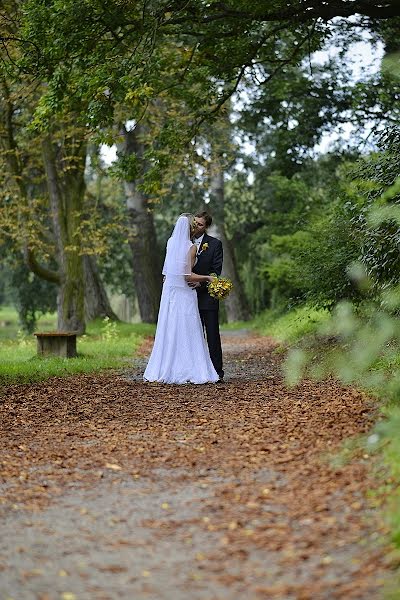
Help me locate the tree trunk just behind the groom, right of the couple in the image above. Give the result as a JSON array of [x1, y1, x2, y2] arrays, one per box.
[[211, 165, 249, 323]]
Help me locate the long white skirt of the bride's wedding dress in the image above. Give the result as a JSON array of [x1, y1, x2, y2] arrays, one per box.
[[143, 217, 219, 384]]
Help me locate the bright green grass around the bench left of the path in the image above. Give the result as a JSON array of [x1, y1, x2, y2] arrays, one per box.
[[0, 308, 155, 384]]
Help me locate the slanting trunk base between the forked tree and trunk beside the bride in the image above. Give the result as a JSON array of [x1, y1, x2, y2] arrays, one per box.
[[83, 256, 118, 322]]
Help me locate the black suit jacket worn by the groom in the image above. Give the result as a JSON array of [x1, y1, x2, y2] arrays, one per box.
[[193, 233, 224, 310]]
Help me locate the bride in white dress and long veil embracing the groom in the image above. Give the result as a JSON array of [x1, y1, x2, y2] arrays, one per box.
[[143, 214, 218, 383]]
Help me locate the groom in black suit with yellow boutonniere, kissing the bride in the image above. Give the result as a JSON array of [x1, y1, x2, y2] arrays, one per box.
[[192, 211, 224, 382]]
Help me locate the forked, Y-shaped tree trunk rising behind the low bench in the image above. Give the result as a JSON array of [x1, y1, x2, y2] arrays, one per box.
[[43, 136, 86, 333]]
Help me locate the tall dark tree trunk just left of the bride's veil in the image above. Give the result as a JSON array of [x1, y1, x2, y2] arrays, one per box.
[[119, 125, 162, 323]]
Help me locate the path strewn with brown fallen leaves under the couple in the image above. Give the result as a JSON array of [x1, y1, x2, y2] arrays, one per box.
[[0, 332, 392, 600]]
